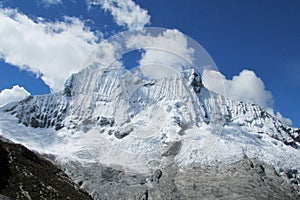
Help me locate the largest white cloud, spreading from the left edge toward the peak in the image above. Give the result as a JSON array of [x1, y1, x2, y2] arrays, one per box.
[[0, 8, 99, 91]]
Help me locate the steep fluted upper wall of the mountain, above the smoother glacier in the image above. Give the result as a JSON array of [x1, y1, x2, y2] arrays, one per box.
[[4, 65, 300, 148]]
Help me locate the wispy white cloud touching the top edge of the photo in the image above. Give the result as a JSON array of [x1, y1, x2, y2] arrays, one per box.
[[89, 0, 150, 30]]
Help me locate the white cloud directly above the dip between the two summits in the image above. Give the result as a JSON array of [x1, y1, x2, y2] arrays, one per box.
[[126, 29, 195, 78]]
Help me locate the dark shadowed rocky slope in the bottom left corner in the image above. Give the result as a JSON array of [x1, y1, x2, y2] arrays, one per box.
[[0, 140, 91, 199]]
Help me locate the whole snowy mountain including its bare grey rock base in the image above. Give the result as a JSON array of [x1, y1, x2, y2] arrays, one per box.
[[0, 63, 300, 199]]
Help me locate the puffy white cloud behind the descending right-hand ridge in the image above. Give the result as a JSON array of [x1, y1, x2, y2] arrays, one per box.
[[202, 70, 292, 125]]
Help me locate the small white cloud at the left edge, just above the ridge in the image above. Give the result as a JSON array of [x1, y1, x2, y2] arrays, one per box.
[[0, 85, 30, 106]]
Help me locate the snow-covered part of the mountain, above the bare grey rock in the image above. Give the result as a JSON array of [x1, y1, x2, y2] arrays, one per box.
[[0, 63, 300, 196]]
